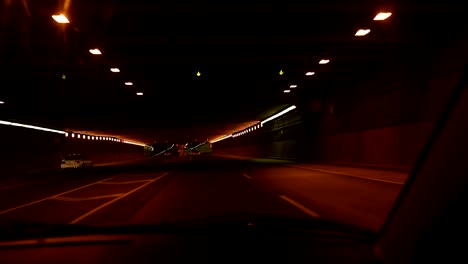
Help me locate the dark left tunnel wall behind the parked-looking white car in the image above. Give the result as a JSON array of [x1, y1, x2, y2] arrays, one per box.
[[0, 125, 144, 174]]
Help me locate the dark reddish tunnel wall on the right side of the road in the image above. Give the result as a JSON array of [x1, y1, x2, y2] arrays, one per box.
[[213, 37, 468, 170]]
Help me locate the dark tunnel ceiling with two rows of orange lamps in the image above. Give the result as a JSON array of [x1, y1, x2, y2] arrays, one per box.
[[0, 0, 462, 143]]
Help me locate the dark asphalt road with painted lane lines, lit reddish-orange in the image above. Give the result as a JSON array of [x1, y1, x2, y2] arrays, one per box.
[[0, 156, 402, 231]]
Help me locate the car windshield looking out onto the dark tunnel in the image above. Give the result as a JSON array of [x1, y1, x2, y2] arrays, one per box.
[[0, 0, 466, 241]]
